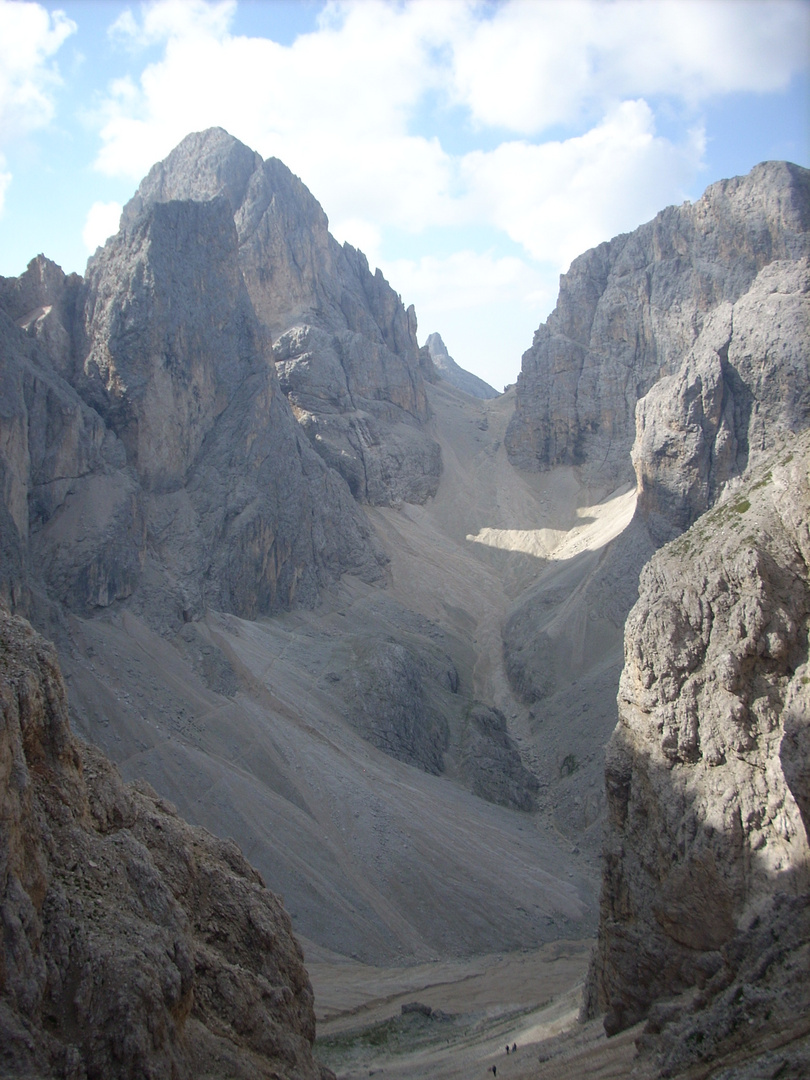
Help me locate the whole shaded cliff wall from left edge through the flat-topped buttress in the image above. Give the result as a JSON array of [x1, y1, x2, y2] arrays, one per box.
[[0, 197, 383, 625]]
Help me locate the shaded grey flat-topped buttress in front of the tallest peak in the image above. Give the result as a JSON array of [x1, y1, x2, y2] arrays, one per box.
[[78, 191, 388, 617]]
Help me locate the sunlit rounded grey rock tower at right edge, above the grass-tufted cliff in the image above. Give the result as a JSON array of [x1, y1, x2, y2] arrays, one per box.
[[633, 251, 810, 543]]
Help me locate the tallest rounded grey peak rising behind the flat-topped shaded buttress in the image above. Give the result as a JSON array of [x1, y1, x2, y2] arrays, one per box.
[[122, 129, 441, 504]]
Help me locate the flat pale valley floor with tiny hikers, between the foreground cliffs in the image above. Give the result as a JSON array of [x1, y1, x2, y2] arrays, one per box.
[[307, 941, 646, 1080]]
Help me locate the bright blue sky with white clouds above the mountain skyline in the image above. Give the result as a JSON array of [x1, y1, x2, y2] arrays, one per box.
[[0, 0, 810, 389]]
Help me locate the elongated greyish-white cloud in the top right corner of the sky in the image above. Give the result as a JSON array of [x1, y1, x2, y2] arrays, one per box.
[[453, 0, 810, 135]]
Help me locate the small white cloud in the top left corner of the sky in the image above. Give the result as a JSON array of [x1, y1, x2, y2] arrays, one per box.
[[0, 0, 76, 143]]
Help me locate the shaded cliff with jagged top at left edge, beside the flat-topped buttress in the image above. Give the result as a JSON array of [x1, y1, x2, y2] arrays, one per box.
[[0, 270, 145, 611]]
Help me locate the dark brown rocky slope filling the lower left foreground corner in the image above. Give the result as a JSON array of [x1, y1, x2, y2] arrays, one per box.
[[0, 612, 330, 1080]]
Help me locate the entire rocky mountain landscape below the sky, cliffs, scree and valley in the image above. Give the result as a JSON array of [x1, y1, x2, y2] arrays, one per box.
[[0, 135, 810, 1080]]
